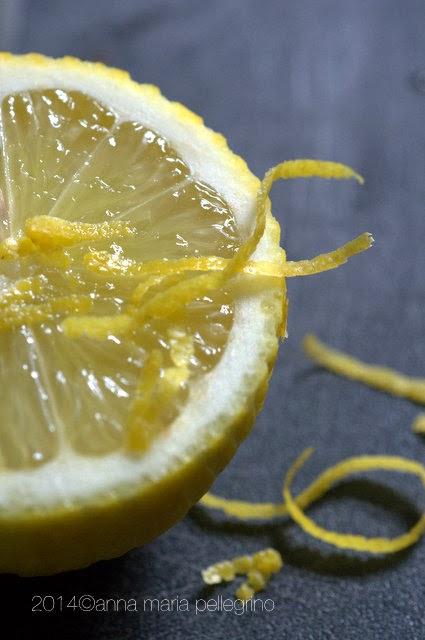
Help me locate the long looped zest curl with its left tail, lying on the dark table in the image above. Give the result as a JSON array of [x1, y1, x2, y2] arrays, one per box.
[[201, 449, 425, 554]]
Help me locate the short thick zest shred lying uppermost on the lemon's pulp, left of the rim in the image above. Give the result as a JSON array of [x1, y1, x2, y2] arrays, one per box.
[[25, 216, 137, 249]]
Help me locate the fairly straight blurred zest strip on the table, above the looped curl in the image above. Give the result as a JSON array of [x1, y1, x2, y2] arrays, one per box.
[[303, 335, 425, 404]]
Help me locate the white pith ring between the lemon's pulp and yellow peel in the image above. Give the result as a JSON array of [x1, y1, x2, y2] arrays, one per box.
[[0, 57, 281, 514]]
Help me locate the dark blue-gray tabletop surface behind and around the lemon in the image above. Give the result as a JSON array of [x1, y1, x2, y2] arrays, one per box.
[[0, 0, 425, 640]]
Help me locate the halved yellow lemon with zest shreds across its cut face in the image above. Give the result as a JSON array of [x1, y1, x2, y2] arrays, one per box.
[[0, 54, 370, 575]]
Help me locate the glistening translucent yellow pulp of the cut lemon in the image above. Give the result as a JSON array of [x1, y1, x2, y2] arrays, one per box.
[[0, 89, 241, 469]]
